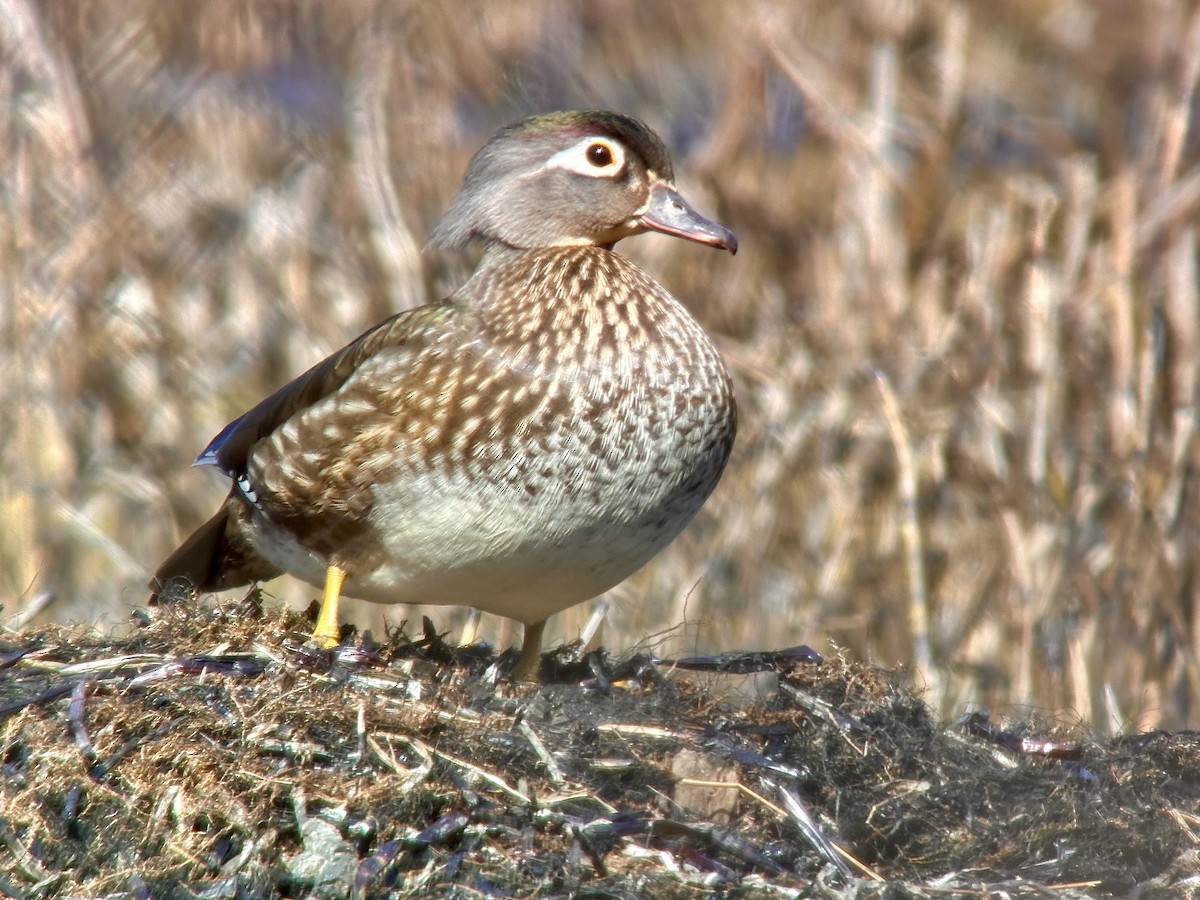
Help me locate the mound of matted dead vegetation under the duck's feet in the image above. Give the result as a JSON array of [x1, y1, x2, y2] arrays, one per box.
[[0, 595, 1200, 898]]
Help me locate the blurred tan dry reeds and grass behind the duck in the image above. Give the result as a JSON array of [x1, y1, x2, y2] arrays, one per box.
[[7, 0, 1200, 731]]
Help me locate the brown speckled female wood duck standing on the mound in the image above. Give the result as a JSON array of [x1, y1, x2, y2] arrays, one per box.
[[151, 112, 737, 679]]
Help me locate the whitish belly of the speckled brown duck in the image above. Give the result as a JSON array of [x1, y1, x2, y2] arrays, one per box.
[[253, 410, 724, 623]]
